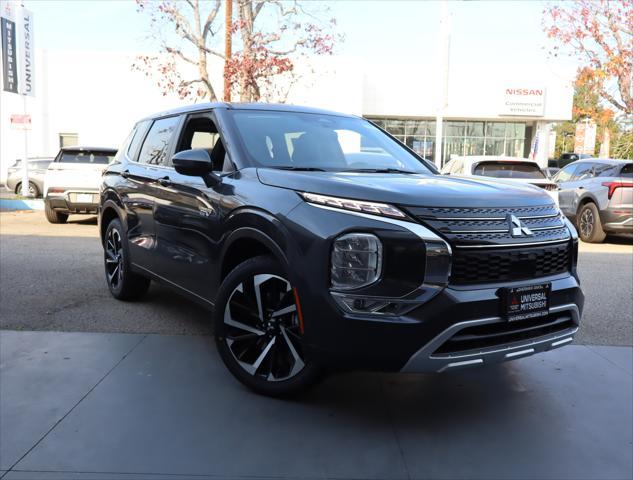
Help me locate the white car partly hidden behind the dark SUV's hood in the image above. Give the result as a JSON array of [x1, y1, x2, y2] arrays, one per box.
[[442, 155, 558, 201]]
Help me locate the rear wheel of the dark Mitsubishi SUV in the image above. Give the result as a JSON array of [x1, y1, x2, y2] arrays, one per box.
[[103, 218, 150, 300]]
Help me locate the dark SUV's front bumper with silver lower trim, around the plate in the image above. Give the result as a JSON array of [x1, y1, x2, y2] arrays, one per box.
[[304, 274, 584, 372]]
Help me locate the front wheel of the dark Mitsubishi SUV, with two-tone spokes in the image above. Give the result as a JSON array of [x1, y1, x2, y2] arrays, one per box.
[[213, 256, 320, 397]]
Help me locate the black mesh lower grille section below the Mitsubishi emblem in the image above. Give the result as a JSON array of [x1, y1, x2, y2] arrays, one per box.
[[451, 242, 571, 285]]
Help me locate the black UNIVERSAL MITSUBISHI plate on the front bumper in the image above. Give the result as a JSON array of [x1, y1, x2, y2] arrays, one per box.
[[501, 283, 552, 322]]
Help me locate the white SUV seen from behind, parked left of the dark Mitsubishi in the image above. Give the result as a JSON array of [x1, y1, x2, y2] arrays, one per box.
[[44, 147, 116, 223]]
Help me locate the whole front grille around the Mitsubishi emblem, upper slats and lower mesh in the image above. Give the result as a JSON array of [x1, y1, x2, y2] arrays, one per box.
[[407, 204, 572, 285]]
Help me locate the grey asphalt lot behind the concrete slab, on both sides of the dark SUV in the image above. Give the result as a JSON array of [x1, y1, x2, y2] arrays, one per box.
[[0, 211, 633, 346]]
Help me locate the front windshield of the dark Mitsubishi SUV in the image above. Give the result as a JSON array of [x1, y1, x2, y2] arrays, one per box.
[[225, 110, 432, 174]]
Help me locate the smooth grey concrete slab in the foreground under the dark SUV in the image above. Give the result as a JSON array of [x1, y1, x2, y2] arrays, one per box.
[[0, 331, 633, 480]]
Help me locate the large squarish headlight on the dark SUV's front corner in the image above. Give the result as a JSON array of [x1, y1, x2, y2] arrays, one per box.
[[331, 233, 382, 290]]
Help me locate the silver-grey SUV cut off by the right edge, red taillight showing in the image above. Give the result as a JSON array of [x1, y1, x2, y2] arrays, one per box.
[[553, 159, 633, 242]]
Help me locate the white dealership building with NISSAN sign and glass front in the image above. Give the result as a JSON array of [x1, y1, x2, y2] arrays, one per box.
[[0, 50, 575, 181]]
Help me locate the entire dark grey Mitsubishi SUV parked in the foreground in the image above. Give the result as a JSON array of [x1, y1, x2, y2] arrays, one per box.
[[100, 103, 583, 395]]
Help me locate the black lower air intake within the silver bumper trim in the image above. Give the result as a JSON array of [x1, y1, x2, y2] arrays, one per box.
[[433, 313, 578, 356]]
